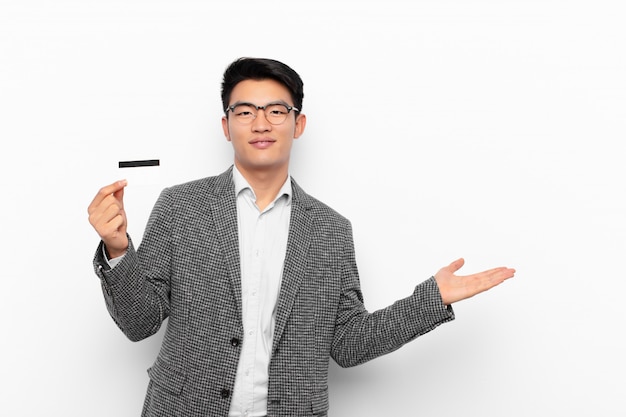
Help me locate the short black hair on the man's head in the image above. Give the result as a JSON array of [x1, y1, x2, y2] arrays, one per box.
[[222, 57, 304, 111]]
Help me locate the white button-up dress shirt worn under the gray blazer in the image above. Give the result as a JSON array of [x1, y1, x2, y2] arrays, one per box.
[[229, 167, 291, 417]]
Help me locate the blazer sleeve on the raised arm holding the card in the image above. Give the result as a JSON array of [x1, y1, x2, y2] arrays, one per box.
[[93, 190, 171, 341]]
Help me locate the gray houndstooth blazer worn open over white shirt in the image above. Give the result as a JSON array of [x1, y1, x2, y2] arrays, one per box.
[[94, 167, 454, 417]]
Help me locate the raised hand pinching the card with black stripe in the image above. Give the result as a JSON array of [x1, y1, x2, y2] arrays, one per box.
[[87, 180, 128, 259]]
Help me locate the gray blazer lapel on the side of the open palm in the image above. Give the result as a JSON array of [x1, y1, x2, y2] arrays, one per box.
[[272, 180, 313, 354]]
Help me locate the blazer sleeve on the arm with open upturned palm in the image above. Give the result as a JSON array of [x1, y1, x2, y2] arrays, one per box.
[[331, 221, 454, 367]]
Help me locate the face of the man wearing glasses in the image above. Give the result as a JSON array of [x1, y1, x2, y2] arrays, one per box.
[[222, 80, 306, 172]]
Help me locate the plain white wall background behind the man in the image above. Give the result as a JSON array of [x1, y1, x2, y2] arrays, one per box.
[[0, 0, 626, 417]]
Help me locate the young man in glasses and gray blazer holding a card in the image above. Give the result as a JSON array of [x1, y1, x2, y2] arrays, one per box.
[[89, 58, 515, 417]]
